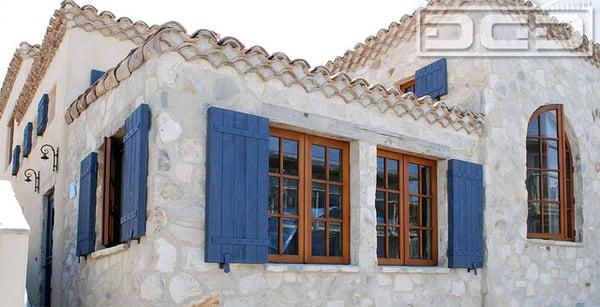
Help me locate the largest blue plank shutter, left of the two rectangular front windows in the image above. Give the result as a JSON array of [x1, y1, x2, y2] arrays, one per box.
[[205, 107, 269, 272]]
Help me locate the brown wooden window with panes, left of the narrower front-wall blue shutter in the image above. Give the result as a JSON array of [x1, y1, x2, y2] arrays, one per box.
[[375, 150, 437, 265]]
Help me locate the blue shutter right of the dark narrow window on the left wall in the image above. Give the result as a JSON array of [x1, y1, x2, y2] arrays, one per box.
[[120, 104, 150, 242]]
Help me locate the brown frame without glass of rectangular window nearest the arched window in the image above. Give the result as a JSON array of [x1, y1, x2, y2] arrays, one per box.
[[375, 149, 438, 266]]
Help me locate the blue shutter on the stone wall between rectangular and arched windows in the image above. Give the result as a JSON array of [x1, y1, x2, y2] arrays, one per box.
[[448, 160, 484, 269]]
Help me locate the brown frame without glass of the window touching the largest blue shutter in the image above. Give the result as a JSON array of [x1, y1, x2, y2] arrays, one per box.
[[268, 127, 350, 264]]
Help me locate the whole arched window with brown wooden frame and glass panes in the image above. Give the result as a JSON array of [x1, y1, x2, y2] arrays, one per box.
[[526, 105, 575, 240]]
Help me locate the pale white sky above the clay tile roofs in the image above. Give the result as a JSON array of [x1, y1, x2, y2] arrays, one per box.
[[0, 0, 426, 74]]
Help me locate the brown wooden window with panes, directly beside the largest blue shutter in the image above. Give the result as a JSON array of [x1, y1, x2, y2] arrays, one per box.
[[269, 128, 350, 264]]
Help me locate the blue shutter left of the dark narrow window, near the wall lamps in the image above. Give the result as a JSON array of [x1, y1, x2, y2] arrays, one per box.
[[77, 152, 98, 256]]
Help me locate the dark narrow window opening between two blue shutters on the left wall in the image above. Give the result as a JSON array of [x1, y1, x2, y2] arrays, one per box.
[[102, 129, 124, 247]]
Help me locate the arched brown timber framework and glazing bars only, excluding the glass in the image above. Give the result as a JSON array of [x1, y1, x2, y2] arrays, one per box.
[[526, 104, 575, 240]]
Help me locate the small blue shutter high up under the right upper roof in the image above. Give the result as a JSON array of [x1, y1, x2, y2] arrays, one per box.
[[415, 58, 448, 99]]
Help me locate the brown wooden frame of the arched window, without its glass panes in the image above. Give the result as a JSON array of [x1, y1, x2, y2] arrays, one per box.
[[526, 104, 575, 241]]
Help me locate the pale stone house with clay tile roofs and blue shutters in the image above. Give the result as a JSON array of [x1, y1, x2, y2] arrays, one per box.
[[0, 0, 600, 306]]
